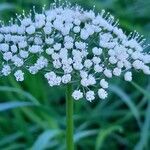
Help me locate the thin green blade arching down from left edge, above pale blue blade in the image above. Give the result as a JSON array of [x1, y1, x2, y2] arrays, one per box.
[[0, 86, 40, 105]]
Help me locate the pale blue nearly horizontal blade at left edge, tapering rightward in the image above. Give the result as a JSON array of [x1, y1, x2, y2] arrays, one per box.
[[0, 102, 34, 112]]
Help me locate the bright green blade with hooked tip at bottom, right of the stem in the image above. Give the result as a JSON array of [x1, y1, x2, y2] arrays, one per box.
[[95, 126, 122, 150]]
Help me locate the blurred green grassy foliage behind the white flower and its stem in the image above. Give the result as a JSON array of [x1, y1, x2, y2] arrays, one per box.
[[0, 0, 150, 150]]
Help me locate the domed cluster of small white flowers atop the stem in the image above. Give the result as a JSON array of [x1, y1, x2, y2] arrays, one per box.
[[0, 2, 150, 102]]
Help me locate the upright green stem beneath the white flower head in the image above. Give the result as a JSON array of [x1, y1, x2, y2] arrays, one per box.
[[66, 84, 74, 150]]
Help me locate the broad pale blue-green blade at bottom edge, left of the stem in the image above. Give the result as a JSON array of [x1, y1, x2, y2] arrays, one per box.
[[31, 130, 61, 150]]
